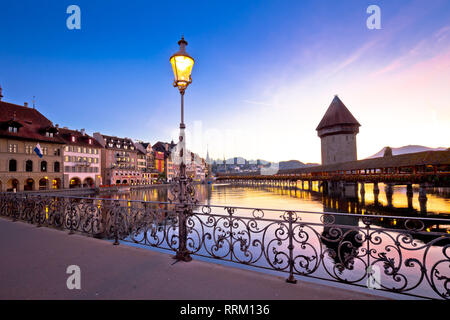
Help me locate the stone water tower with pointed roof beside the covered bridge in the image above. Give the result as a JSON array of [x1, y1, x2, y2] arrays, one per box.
[[316, 96, 361, 165]]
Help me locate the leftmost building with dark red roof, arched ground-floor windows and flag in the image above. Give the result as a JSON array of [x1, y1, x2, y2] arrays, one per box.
[[0, 97, 65, 192]]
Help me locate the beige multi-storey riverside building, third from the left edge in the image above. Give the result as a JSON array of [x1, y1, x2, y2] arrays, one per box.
[[93, 132, 142, 185]]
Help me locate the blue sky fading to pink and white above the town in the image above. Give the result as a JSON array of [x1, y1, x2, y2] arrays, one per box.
[[0, 0, 450, 162]]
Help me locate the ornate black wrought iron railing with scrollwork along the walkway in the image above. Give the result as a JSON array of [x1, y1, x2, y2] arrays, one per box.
[[0, 194, 450, 299]]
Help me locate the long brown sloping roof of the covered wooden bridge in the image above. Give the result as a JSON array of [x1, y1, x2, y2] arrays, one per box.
[[278, 150, 450, 174]]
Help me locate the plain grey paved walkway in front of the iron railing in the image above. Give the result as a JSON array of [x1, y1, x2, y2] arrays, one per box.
[[0, 218, 383, 300]]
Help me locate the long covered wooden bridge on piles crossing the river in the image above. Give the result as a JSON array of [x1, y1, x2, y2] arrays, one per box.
[[217, 150, 450, 212]]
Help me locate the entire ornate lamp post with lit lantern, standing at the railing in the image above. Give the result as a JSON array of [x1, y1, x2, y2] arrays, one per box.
[[170, 36, 194, 261]]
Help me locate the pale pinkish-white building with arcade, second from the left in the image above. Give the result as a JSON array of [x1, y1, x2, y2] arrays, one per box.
[[59, 127, 102, 188]]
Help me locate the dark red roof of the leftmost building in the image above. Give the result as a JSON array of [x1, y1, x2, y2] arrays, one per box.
[[0, 101, 64, 143]]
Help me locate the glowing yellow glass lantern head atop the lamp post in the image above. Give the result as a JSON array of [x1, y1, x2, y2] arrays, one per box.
[[170, 37, 194, 92]]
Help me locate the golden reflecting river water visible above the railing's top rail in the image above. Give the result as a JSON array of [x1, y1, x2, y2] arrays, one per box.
[[101, 183, 450, 216]]
